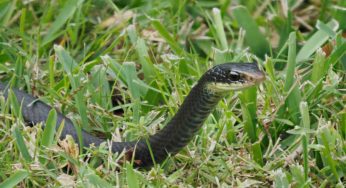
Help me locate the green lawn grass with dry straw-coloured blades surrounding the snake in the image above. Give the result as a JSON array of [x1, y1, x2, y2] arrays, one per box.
[[0, 0, 346, 187]]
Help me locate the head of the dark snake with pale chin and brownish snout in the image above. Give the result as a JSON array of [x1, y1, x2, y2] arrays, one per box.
[[202, 63, 265, 92]]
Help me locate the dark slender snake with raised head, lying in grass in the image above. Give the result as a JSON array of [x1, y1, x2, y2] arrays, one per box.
[[0, 62, 265, 168]]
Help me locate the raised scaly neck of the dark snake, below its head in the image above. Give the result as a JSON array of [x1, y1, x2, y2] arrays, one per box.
[[136, 82, 225, 166]]
